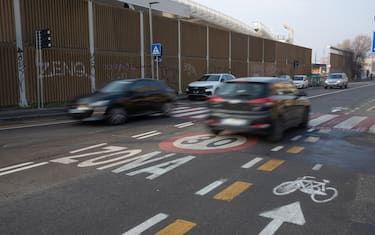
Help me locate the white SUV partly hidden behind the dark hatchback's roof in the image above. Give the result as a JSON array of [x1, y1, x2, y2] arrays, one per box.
[[186, 73, 236, 100]]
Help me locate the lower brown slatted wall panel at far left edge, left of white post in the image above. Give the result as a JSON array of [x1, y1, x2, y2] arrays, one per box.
[[0, 44, 19, 106]]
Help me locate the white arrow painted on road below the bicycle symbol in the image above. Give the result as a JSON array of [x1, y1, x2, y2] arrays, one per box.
[[259, 202, 306, 235]]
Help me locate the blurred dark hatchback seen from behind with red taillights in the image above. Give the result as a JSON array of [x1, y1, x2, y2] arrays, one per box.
[[206, 77, 310, 141]]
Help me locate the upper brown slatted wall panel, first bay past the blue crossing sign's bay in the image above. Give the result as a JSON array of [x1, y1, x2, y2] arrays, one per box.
[[181, 21, 207, 58]]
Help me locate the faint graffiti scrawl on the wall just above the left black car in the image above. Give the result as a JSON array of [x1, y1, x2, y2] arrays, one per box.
[[103, 63, 137, 80]]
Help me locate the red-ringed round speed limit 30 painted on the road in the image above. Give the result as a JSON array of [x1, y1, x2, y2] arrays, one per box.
[[159, 133, 257, 154]]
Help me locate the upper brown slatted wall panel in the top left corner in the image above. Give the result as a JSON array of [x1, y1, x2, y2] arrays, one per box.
[[0, 0, 16, 43]]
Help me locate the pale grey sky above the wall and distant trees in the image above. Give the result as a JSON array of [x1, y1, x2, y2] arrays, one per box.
[[194, 0, 375, 63]]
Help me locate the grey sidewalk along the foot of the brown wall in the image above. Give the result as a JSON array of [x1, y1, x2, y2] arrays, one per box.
[[0, 95, 186, 124]]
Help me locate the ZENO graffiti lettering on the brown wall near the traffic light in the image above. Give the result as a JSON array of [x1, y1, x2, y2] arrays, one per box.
[[41, 61, 88, 78]]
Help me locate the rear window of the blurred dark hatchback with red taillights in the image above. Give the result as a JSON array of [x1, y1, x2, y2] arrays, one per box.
[[216, 82, 266, 99]]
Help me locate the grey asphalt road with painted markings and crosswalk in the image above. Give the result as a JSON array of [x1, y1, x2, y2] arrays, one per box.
[[0, 82, 375, 235]]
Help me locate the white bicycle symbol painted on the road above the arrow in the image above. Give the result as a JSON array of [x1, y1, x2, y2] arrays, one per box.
[[273, 176, 338, 203]]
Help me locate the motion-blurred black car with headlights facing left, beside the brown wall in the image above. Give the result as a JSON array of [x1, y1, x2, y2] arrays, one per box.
[[68, 78, 176, 125]]
